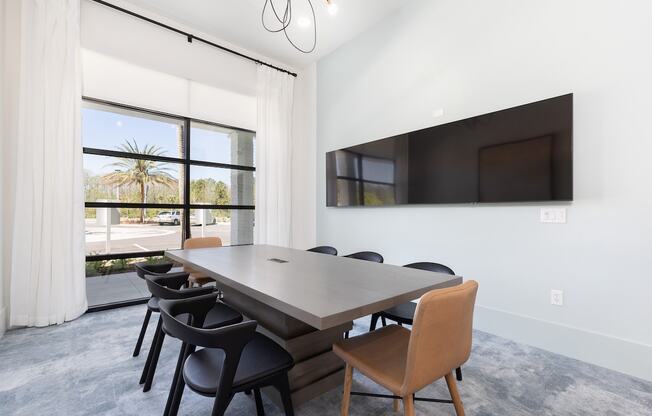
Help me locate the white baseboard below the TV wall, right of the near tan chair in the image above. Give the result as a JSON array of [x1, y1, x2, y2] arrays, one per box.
[[474, 305, 652, 381]]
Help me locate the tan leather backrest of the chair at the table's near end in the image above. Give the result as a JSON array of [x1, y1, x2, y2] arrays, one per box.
[[401, 280, 478, 394]]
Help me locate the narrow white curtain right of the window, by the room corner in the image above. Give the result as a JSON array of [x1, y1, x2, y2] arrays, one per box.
[[254, 65, 294, 247]]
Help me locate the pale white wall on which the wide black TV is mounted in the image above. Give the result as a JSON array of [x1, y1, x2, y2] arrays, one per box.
[[317, 0, 652, 379]]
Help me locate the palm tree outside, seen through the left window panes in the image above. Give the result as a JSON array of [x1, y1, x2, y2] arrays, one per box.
[[102, 139, 178, 223]]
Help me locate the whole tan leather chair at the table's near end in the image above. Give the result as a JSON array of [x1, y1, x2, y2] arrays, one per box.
[[333, 280, 478, 416]]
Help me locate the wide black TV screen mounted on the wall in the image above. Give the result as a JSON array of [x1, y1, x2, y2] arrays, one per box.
[[326, 94, 573, 207]]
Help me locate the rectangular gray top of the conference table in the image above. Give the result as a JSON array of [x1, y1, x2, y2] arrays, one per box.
[[165, 245, 462, 329]]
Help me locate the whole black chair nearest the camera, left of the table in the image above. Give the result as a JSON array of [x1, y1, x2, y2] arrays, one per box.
[[160, 294, 294, 416]]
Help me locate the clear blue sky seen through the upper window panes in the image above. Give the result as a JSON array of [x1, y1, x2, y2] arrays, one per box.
[[82, 106, 255, 184]]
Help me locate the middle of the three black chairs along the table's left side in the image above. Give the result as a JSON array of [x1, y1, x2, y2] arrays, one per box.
[[140, 272, 242, 392]]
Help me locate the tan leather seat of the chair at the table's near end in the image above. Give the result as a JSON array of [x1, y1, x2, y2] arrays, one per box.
[[333, 325, 410, 394]]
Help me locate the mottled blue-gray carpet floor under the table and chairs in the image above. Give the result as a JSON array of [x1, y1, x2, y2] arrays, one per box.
[[0, 305, 652, 416]]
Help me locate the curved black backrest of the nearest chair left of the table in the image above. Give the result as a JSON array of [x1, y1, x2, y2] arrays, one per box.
[[159, 294, 258, 396]]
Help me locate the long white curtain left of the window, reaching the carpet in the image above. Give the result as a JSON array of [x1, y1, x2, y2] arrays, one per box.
[[3, 0, 87, 326]]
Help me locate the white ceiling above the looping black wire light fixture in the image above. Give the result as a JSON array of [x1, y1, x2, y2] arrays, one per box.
[[121, 0, 407, 68]]
